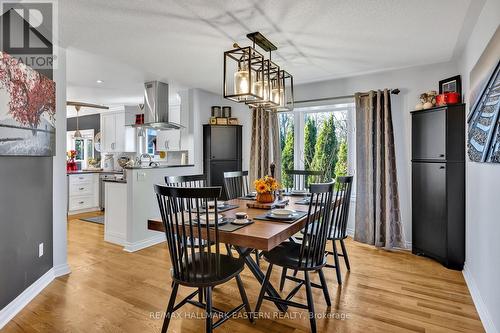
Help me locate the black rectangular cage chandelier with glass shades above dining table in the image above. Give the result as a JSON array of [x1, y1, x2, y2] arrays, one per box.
[[224, 32, 293, 112]]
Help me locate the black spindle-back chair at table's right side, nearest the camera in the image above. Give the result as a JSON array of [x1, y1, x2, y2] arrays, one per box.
[[255, 182, 335, 332]]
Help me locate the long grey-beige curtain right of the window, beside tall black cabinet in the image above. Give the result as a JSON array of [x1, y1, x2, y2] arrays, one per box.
[[354, 89, 404, 249]]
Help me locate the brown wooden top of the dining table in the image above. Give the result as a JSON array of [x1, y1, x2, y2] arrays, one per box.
[[148, 196, 308, 251]]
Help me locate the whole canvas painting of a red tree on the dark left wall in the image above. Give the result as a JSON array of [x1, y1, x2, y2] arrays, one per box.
[[0, 52, 56, 156]]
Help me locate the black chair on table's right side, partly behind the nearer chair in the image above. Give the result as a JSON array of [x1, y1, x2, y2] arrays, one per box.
[[280, 176, 353, 291]]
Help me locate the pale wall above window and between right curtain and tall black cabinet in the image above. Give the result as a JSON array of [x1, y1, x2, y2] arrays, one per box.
[[295, 62, 457, 247]]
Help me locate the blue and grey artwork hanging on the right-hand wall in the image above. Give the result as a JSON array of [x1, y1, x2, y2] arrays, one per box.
[[467, 28, 500, 163]]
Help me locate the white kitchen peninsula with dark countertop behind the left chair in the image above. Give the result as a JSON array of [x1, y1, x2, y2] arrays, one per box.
[[104, 164, 195, 252]]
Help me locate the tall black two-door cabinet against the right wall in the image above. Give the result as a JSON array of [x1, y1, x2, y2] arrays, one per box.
[[411, 104, 465, 270]]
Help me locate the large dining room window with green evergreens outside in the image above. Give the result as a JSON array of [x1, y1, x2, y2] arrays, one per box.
[[279, 103, 354, 187]]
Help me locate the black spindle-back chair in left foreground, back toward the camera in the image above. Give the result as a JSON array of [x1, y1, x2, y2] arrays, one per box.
[[154, 185, 253, 333]]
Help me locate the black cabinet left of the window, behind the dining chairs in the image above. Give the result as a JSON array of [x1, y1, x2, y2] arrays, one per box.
[[203, 124, 242, 200]]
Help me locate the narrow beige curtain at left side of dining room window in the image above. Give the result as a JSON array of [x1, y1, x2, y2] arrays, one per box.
[[248, 109, 271, 186]]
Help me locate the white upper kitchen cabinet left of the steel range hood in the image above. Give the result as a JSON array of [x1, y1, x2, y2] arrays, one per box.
[[101, 111, 136, 153]]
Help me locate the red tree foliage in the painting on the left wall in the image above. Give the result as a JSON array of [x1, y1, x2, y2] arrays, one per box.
[[0, 52, 56, 135]]
